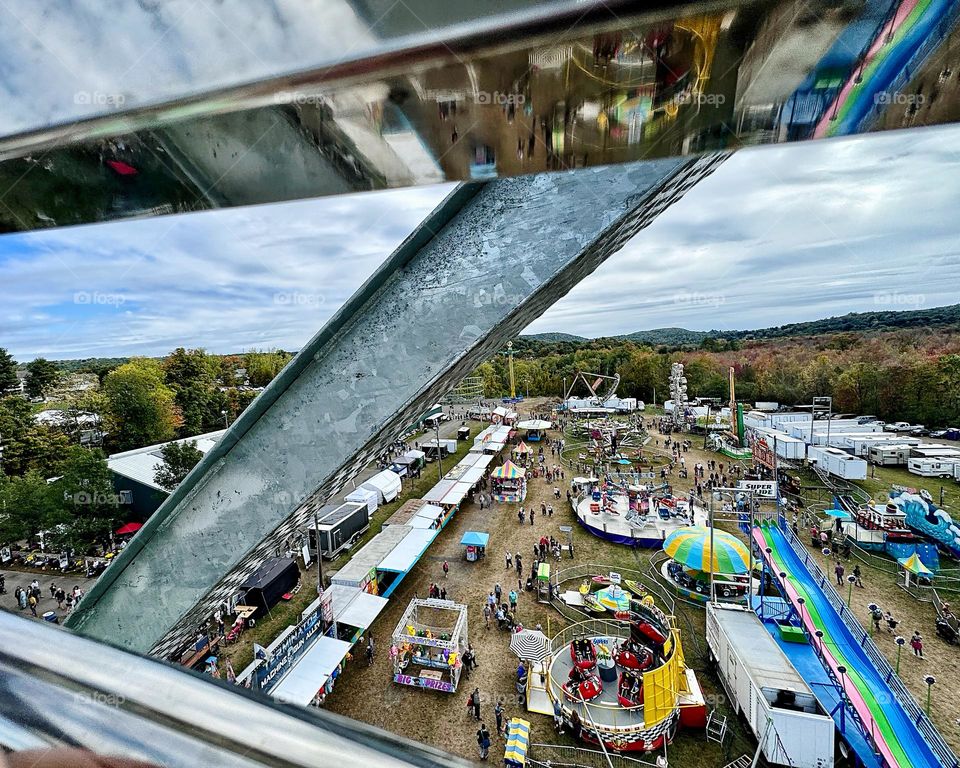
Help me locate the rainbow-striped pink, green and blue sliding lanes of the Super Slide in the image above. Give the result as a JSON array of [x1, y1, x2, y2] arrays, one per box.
[[753, 526, 944, 768]]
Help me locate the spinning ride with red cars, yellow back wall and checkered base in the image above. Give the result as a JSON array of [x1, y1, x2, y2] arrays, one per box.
[[549, 596, 706, 751]]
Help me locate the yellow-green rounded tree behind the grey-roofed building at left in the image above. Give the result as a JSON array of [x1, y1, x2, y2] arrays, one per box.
[[103, 358, 180, 450]]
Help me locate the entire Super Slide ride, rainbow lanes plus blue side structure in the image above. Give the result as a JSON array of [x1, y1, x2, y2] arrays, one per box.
[[753, 524, 949, 768]]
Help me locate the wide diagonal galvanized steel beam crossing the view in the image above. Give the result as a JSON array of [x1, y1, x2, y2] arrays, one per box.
[[69, 154, 727, 654]]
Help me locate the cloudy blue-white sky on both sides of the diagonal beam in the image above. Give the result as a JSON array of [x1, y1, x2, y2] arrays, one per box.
[[0, 124, 960, 361]]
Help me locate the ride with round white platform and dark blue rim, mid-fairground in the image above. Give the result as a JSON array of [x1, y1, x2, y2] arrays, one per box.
[[571, 478, 707, 549]]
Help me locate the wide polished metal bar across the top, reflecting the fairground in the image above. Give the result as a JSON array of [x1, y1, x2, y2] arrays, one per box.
[[0, 0, 960, 232]]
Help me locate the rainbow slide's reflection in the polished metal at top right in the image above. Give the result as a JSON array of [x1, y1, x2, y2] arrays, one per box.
[[814, 0, 954, 138]]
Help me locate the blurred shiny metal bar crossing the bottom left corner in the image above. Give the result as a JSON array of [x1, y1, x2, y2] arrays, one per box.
[[0, 611, 466, 768]]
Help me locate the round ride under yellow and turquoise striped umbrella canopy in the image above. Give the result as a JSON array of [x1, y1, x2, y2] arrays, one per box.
[[660, 526, 758, 603]]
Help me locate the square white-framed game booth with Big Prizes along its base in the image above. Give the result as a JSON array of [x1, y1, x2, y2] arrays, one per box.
[[390, 598, 467, 693]]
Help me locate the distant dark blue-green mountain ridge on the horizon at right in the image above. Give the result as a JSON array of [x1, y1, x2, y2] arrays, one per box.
[[523, 304, 960, 346]]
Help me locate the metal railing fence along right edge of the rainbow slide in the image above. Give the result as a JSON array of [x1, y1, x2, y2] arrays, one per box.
[[783, 526, 960, 768]]
